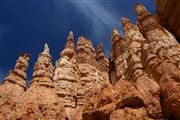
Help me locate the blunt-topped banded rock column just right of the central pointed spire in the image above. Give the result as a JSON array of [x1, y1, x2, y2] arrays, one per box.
[[76, 37, 105, 106]]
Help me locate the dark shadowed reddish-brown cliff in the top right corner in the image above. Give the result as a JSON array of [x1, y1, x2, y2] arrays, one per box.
[[155, 0, 180, 41]]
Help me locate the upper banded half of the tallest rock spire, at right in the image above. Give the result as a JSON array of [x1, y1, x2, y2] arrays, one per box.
[[135, 4, 180, 68]]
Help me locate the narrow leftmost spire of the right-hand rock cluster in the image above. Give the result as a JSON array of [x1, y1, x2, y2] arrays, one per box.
[[110, 28, 127, 81]]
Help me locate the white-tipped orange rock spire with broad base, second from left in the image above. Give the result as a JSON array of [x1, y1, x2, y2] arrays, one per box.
[[11, 44, 65, 120]]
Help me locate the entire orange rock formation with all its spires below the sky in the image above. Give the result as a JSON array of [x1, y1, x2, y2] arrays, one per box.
[[0, 0, 180, 120]]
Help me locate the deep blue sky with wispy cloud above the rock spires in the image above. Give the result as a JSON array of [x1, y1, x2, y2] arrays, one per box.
[[0, 0, 155, 81]]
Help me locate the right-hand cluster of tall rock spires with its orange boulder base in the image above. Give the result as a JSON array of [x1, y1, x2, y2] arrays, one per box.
[[83, 4, 180, 120]]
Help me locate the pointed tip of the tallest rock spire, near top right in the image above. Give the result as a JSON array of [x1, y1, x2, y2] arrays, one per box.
[[135, 3, 151, 21]]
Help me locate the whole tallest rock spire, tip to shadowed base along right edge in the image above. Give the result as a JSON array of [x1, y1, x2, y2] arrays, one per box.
[[136, 5, 180, 118]]
